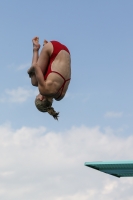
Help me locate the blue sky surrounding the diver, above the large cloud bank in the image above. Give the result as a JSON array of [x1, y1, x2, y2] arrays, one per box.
[[0, 1, 133, 134]]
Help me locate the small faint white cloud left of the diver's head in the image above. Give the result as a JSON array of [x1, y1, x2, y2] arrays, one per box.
[[0, 87, 38, 103]]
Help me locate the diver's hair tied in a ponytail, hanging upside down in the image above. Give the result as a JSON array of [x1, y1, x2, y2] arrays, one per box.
[[35, 98, 59, 120]]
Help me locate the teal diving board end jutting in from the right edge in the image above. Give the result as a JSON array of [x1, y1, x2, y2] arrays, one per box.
[[84, 160, 133, 178]]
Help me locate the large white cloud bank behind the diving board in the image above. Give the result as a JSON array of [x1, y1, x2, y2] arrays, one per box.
[[0, 125, 133, 200]]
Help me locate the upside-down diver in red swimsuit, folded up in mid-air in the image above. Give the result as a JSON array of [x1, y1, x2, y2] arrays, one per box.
[[28, 37, 71, 119]]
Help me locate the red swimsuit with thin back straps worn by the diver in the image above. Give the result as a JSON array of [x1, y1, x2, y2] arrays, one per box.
[[44, 41, 70, 100]]
